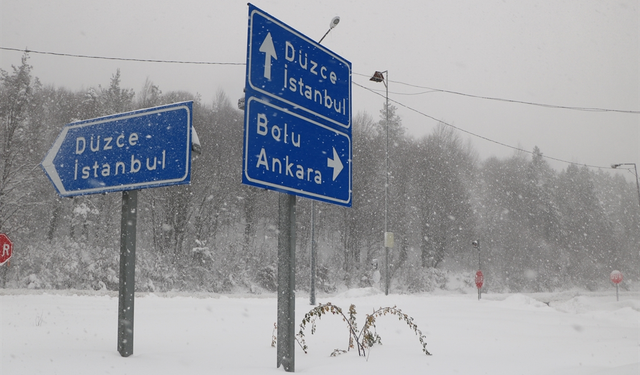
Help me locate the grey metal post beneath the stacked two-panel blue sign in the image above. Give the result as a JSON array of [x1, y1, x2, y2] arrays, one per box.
[[277, 193, 296, 372]]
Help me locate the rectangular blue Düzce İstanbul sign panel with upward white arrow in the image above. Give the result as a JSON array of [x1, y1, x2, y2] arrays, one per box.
[[246, 4, 352, 129]]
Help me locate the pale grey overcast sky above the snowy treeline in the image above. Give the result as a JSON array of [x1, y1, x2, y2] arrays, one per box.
[[0, 0, 640, 173]]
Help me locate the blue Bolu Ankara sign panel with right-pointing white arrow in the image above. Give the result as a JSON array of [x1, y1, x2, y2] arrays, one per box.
[[242, 98, 351, 207]]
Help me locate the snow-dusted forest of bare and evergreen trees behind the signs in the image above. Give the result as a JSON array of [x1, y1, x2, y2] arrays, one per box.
[[0, 54, 640, 292]]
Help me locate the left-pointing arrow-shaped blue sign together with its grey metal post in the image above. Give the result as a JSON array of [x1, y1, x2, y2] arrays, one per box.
[[41, 102, 197, 357]]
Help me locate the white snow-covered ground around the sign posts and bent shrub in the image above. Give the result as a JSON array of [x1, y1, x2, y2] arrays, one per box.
[[0, 288, 640, 375]]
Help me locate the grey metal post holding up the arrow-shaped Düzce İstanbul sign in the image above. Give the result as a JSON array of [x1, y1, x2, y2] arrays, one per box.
[[118, 190, 138, 357]]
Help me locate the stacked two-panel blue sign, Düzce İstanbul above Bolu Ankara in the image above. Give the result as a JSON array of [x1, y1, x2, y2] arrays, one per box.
[[242, 4, 352, 207]]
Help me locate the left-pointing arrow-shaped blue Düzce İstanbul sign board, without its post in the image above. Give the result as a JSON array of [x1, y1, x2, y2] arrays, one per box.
[[41, 102, 193, 197]]
